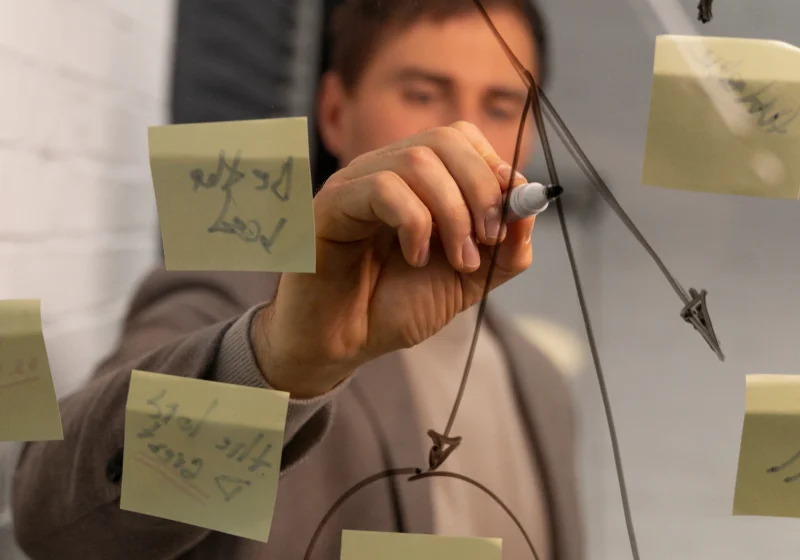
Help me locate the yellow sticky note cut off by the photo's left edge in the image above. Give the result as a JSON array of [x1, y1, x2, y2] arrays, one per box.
[[0, 299, 64, 441]]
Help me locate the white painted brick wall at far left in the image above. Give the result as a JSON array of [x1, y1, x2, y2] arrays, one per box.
[[0, 0, 174, 559]]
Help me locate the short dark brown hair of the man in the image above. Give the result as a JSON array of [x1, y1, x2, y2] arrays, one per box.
[[329, 0, 549, 90]]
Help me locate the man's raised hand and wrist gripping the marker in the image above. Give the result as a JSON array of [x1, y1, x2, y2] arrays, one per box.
[[253, 122, 534, 398]]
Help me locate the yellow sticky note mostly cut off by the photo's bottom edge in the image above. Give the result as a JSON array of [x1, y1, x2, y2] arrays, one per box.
[[341, 531, 503, 560]]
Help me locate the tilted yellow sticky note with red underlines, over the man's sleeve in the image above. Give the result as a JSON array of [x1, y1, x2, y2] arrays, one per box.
[[120, 371, 289, 542]]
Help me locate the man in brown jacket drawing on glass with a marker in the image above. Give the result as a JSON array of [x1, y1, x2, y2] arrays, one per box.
[[7, 0, 582, 560]]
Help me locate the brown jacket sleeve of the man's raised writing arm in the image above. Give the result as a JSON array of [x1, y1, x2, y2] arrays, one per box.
[[12, 271, 338, 560]]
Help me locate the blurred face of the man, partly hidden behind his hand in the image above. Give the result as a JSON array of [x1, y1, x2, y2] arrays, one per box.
[[319, 8, 537, 167]]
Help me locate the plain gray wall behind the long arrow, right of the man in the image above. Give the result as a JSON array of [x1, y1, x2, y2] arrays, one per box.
[[497, 0, 800, 560]]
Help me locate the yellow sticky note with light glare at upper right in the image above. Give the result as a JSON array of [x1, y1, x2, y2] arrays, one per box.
[[642, 35, 800, 199]]
